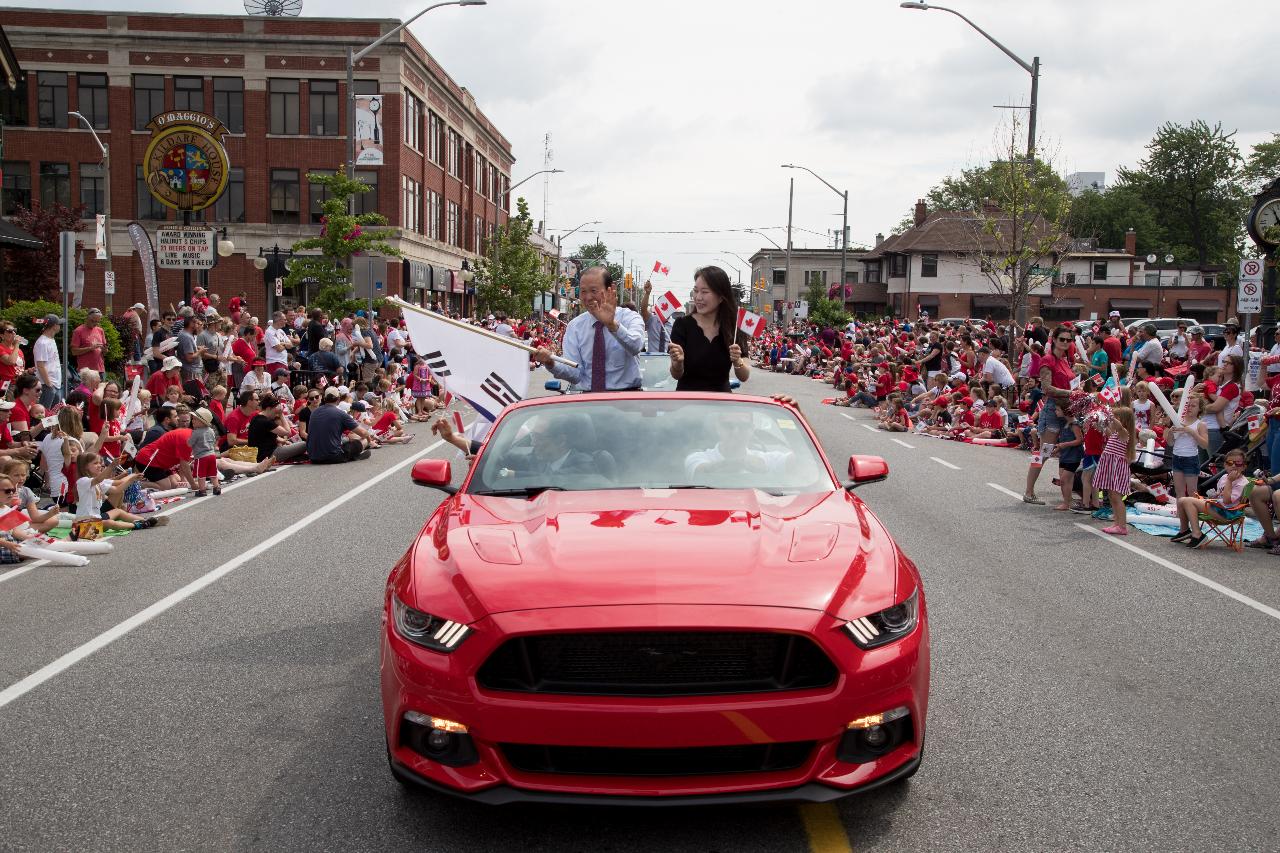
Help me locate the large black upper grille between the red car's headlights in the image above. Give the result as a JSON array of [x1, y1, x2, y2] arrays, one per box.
[[476, 631, 836, 697]]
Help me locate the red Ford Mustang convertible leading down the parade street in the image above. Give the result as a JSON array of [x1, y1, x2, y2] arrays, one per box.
[[381, 393, 929, 804]]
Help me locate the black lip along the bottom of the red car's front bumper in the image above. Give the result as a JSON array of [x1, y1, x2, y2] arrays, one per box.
[[392, 753, 920, 808]]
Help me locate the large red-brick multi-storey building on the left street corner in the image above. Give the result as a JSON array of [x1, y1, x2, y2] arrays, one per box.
[[0, 8, 515, 313]]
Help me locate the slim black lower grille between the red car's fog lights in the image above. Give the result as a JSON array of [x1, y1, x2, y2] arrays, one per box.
[[500, 740, 814, 776]]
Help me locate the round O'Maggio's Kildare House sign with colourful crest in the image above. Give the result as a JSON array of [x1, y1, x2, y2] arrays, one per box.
[[142, 110, 230, 211]]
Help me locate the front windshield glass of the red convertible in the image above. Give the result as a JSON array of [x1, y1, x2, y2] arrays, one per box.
[[467, 397, 836, 497]]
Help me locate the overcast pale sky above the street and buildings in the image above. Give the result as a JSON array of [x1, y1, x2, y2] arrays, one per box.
[[12, 0, 1280, 284]]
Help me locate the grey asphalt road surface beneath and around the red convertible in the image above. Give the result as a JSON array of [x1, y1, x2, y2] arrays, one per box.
[[0, 371, 1280, 853]]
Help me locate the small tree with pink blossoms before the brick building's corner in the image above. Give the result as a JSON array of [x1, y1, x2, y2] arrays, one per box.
[[284, 169, 399, 302]]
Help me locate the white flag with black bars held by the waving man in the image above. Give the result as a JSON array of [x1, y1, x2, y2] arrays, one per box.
[[397, 302, 529, 421]]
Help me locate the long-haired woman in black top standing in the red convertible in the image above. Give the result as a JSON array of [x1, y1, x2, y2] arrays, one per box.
[[667, 266, 751, 392]]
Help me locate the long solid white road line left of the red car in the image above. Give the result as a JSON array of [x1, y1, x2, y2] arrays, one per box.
[[0, 441, 444, 708]]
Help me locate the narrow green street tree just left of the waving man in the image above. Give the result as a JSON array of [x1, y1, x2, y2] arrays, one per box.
[[476, 199, 552, 316]]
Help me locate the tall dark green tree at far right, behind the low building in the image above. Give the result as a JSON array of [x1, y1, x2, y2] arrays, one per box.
[[1116, 120, 1248, 266]]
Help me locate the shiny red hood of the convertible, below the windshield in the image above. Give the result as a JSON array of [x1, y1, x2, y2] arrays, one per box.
[[413, 489, 897, 619]]
